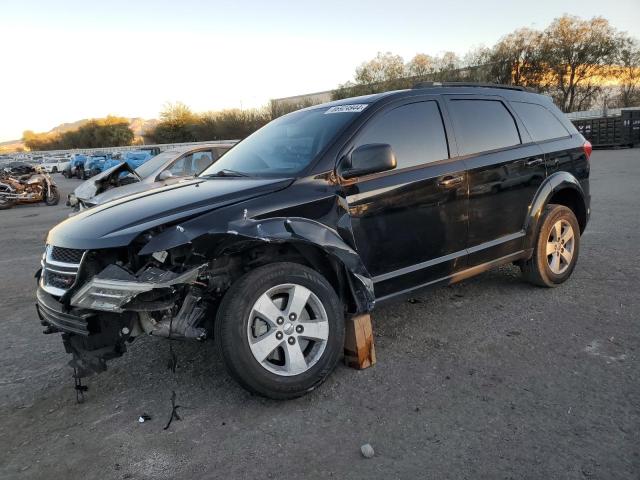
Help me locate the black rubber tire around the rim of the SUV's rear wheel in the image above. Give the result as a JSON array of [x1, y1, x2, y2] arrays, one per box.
[[536, 205, 580, 285]]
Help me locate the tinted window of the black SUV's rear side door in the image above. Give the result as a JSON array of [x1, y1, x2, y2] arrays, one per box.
[[449, 100, 520, 155]]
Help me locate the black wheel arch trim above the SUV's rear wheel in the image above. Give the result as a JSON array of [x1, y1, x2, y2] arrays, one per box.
[[524, 172, 589, 248]]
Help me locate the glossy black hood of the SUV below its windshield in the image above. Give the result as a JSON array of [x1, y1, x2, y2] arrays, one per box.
[[47, 177, 293, 250]]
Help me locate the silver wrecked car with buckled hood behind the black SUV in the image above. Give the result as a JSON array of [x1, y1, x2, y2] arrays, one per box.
[[67, 142, 233, 210]]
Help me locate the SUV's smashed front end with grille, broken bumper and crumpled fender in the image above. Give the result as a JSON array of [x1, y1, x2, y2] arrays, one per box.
[[37, 186, 375, 378]]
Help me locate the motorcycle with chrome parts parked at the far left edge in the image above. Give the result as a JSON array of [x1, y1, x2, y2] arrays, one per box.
[[0, 163, 60, 210]]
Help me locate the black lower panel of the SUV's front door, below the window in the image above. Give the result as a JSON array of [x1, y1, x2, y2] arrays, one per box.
[[346, 161, 467, 297]]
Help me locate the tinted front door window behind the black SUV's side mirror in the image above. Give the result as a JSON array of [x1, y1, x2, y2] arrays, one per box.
[[356, 102, 449, 168]]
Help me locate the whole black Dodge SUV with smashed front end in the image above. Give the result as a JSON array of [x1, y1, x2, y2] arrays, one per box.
[[37, 85, 591, 398]]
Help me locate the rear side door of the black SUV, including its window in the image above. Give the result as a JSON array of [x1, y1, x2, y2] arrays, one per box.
[[447, 95, 546, 266]]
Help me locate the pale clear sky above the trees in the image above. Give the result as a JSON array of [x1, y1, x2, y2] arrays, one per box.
[[0, 0, 640, 141]]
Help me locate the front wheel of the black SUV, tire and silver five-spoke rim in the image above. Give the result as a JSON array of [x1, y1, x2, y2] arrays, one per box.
[[215, 262, 344, 400]]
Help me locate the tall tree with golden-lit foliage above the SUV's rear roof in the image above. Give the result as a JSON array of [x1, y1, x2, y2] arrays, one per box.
[[540, 15, 620, 112]]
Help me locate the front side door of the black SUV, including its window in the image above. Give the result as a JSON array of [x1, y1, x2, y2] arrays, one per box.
[[343, 97, 467, 299]]
